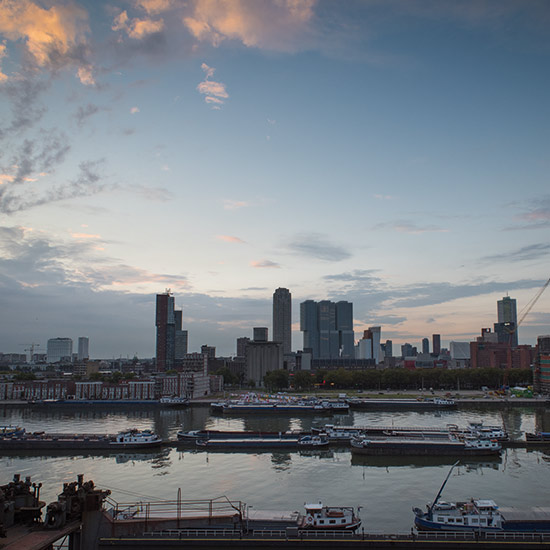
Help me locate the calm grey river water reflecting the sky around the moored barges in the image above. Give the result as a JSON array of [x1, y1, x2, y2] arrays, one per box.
[[0, 407, 550, 533]]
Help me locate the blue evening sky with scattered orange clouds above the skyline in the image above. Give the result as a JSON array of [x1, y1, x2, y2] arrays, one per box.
[[0, 0, 550, 358]]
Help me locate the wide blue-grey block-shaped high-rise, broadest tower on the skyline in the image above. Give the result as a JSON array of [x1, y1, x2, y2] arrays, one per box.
[[300, 300, 355, 359]]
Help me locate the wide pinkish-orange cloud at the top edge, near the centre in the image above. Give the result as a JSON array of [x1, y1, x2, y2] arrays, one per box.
[[183, 0, 317, 52]]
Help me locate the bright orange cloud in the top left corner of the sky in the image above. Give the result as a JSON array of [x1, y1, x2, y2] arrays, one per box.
[[0, 0, 89, 78]]
